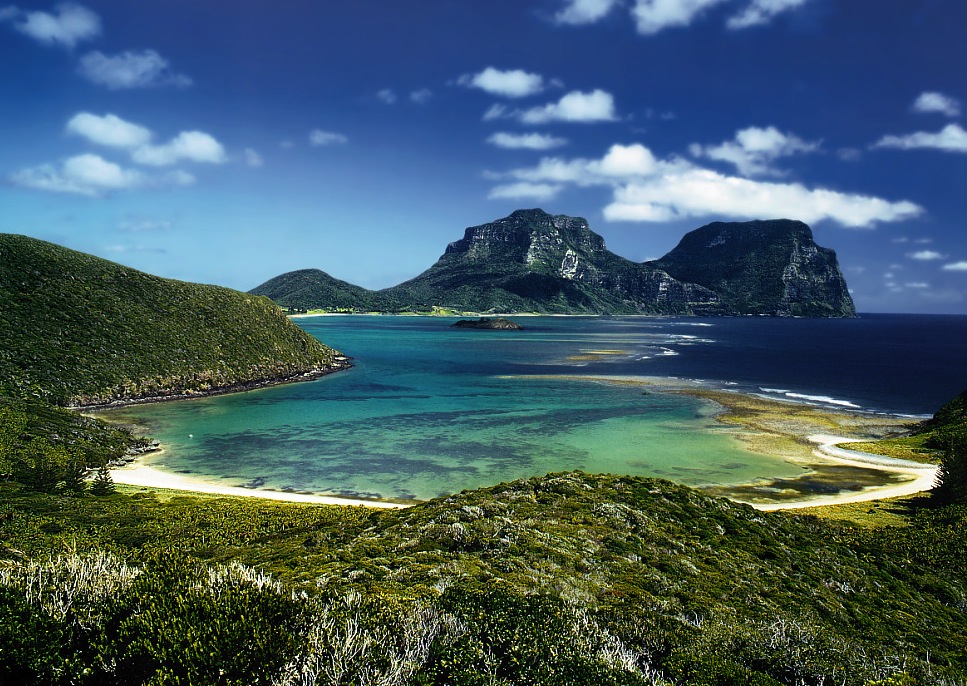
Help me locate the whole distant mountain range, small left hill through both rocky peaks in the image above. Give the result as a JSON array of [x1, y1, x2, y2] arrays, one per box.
[[251, 209, 855, 317]]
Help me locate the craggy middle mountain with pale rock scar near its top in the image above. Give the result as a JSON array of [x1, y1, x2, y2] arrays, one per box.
[[384, 209, 724, 314]]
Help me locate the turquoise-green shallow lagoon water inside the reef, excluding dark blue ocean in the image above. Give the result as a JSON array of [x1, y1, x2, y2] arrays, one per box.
[[102, 316, 802, 500]]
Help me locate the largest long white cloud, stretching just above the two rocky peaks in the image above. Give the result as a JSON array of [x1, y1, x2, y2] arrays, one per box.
[[502, 144, 923, 227]]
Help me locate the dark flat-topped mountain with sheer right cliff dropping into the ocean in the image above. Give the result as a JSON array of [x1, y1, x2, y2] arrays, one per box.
[[647, 219, 856, 317]]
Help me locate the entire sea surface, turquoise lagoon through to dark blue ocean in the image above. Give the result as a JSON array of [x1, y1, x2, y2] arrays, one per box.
[[111, 315, 967, 499]]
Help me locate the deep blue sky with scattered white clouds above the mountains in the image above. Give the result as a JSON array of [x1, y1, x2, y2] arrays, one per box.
[[0, 0, 967, 314]]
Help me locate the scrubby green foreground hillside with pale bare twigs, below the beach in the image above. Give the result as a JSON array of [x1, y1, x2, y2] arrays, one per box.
[[0, 473, 967, 686]]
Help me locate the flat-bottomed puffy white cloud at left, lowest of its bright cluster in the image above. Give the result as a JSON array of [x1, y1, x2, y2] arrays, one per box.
[[11, 154, 147, 196]]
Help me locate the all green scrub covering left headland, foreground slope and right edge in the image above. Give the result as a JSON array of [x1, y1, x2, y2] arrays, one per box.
[[0, 236, 967, 686]]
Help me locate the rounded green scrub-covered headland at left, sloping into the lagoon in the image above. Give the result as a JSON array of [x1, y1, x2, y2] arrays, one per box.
[[0, 234, 345, 405]]
